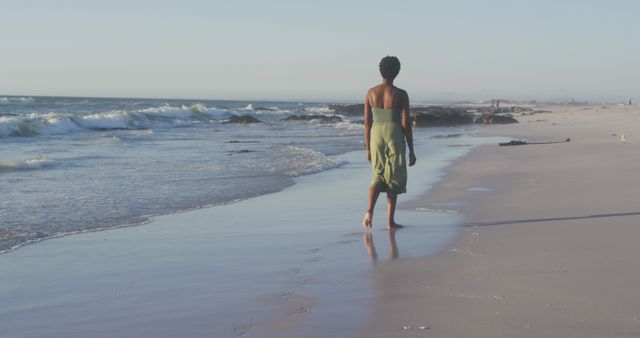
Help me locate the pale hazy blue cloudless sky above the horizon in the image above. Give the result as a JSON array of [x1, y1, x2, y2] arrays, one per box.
[[0, 0, 640, 101]]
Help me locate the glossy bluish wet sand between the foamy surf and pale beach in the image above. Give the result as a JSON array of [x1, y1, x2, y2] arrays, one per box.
[[0, 130, 502, 337]]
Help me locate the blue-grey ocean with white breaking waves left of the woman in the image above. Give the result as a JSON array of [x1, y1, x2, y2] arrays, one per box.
[[0, 96, 362, 252]]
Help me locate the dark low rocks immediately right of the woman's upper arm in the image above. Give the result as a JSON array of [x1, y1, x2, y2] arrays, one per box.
[[412, 106, 473, 127]]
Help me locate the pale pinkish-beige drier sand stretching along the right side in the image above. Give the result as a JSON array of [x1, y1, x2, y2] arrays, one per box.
[[359, 106, 640, 338]]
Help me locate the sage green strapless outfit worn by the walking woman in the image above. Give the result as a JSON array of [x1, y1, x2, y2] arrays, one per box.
[[369, 108, 407, 194]]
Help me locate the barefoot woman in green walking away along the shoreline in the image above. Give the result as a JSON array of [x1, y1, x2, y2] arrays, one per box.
[[362, 56, 416, 229]]
